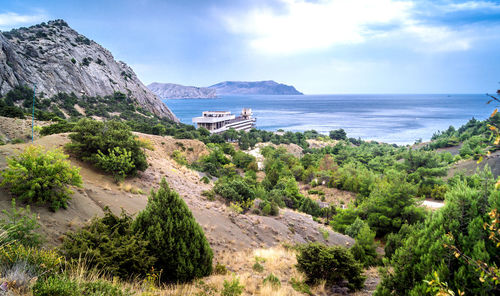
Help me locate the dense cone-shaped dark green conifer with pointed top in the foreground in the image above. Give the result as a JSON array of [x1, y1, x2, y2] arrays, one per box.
[[133, 179, 213, 282]]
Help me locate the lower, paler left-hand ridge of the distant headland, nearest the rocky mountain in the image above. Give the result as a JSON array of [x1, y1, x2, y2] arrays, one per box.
[[148, 82, 217, 99]]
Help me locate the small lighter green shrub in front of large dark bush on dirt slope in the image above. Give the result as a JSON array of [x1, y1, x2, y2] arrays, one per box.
[[95, 147, 135, 182]]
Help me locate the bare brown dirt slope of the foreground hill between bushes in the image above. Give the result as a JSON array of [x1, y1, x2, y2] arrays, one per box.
[[0, 133, 354, 253]]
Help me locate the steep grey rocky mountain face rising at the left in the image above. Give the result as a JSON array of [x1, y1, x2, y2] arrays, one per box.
[[0, 20, 178, 121]]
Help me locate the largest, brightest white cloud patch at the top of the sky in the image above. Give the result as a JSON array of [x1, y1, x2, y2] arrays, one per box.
[[223, 0, 413, 53]]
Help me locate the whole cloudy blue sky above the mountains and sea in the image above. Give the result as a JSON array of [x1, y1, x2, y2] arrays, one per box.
[[0, 0, 500, 94]]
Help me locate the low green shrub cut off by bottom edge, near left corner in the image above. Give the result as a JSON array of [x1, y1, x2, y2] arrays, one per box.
[[33, 276, 78, 296]]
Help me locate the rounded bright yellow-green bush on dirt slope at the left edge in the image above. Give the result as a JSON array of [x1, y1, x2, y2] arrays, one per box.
[[0, 146, 82, 211]]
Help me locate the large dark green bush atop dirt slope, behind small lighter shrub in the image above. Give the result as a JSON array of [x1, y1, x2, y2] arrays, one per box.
[[67, 118, 148, 175]]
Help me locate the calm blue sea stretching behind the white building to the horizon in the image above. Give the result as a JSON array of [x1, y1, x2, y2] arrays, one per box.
[[165, 94, 494, 144]]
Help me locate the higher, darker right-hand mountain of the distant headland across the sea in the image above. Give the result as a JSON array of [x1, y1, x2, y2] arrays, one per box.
[[210, 80, 303, 95]]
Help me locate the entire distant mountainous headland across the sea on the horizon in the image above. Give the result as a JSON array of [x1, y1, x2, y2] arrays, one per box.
[[148, 80, 303, 99]]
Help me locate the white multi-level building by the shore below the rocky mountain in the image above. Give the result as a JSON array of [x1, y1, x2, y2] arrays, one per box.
[[193, 108, 256, 133]]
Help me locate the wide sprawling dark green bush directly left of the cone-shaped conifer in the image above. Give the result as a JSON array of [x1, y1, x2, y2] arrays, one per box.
[[60, 209, 156, 279]]
